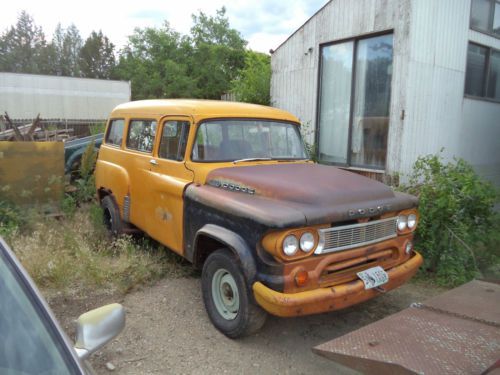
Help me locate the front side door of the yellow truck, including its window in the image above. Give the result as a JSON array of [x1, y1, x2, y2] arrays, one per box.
[[147, 116, 194, 254]]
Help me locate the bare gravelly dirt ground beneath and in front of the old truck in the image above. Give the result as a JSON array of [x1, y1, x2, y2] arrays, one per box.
[[51, 278, 440, 374]]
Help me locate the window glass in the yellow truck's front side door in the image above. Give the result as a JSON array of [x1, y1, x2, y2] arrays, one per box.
[[158, 120, 189, 161]]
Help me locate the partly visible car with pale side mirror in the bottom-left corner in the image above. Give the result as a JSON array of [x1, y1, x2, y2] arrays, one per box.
[[0, 237, 125, 375]]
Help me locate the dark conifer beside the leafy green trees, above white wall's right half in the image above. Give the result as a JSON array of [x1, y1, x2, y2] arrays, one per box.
[[79, 31, 115, 79]]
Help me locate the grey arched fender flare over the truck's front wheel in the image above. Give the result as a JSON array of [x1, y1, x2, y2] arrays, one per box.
[[192, 224, 257, 285]]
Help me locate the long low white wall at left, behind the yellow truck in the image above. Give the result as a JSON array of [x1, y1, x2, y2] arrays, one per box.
[[0, 73, 130, 120]]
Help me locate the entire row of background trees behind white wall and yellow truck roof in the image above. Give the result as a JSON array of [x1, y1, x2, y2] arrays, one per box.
[[0, 7, 270, 104]]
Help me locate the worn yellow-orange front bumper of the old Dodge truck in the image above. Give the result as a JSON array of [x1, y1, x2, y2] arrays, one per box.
[[253, 252, 423, 317]]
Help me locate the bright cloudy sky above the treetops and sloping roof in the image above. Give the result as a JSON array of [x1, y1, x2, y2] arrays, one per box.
[[4, 0, 328, 53]]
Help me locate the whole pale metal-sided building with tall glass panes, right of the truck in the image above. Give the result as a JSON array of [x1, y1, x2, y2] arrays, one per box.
[[271, 0, 500, 186]]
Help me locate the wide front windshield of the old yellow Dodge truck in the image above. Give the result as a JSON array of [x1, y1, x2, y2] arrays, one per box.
[[192, 120, 308, 162]]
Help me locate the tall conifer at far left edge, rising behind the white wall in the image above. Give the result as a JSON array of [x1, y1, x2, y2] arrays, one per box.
[[0, 11, 49, 73]]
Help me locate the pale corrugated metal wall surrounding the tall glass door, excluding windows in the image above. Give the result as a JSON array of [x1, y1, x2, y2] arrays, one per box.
[[271, 0, 500, 186]]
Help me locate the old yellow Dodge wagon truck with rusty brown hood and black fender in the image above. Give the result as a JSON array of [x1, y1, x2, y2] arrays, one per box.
[[95, 100, 422, 338]]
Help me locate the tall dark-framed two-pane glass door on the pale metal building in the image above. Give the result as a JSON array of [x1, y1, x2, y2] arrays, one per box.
[[318, 34, 392, 169]]
